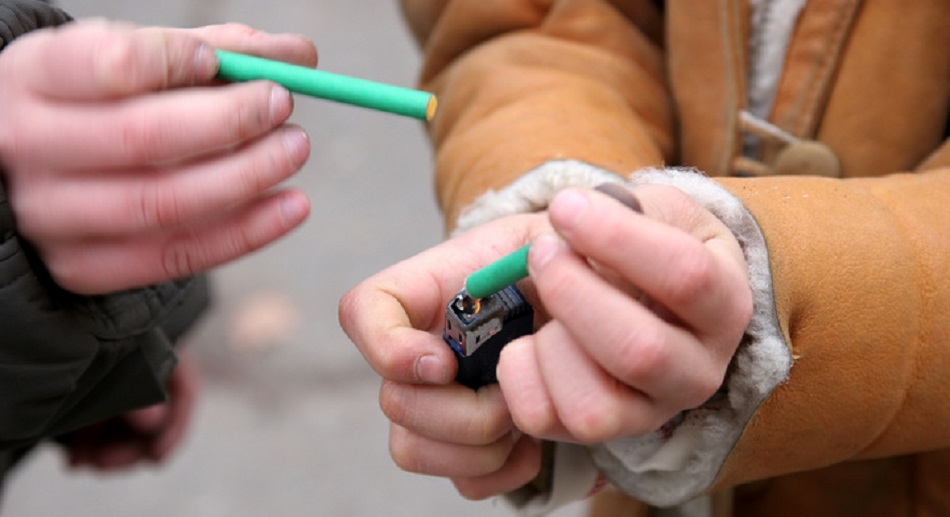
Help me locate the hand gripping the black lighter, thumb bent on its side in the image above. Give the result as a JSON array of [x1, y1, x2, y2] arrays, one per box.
[[340, 214, 551, 498]]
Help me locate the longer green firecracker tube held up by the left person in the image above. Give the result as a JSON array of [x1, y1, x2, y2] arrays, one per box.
[[215, 50, 437, 121]]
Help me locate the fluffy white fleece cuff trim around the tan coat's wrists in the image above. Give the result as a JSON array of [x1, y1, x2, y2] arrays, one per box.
[[457, 160, 791, 508]]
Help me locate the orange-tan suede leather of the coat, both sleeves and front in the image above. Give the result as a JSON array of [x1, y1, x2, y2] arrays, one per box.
[[403, 0, 950, 517]]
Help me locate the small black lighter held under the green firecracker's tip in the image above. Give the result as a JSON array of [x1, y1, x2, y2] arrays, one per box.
[[442, 285, 534, 390]]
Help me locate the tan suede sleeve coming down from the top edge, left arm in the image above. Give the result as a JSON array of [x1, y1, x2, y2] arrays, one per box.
[[402, 0, 674, 228]]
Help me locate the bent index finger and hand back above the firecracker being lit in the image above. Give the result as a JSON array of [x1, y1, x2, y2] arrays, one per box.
[[549, 186, 751, 341]]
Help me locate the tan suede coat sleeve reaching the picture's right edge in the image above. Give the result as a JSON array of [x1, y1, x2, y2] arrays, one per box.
[[719, 167, 950, 490]]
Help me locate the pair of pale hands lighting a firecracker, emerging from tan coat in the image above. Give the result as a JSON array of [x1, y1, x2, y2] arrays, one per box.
[[340, 186, 752, 499]]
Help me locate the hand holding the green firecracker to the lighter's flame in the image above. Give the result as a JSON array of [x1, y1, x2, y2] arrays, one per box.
[[497, 186, 752, 444]]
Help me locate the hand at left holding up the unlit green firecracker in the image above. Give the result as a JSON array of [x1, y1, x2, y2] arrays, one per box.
[[0, 21, 317, 294]]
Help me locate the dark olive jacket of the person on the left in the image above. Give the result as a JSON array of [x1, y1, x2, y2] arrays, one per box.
[[0, 0, 208, 488]]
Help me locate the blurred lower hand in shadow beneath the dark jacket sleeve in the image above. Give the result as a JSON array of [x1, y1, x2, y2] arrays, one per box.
[[61, 355, 198, 471]]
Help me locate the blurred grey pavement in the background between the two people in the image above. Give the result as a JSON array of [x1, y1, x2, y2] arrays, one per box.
[[2, 0, 581, 517]]
